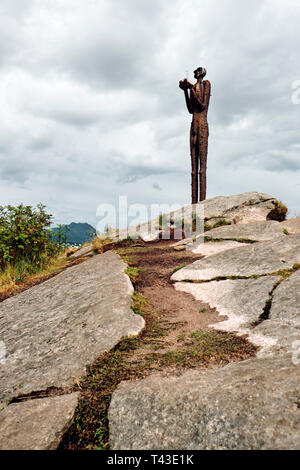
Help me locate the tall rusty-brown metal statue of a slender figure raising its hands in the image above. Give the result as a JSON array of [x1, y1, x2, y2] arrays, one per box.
[[179, 67, 211, 204]]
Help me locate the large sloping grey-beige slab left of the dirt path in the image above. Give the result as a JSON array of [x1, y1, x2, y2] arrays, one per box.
[[0, 251, 144, 403]]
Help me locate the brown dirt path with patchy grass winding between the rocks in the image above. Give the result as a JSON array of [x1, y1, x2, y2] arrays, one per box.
[[61, 241, 256, 450]]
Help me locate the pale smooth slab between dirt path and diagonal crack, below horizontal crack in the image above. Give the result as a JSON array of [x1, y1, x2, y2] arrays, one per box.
[[175, 276, 280, 355]]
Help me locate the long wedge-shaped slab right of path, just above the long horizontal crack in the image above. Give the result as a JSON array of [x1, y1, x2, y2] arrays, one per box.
[[171, 235, 300, 281]]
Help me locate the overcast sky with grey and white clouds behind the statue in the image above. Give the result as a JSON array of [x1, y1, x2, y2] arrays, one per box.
[[0, 0, 300, 226]]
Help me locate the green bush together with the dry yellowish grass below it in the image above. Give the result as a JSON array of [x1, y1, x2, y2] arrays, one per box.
[[0, 204, 67, 298]]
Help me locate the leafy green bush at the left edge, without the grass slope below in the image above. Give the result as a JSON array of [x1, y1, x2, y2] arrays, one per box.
[[0, 204, 64, 270]]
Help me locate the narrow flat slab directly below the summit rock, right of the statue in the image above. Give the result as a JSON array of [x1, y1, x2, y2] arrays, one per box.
[[205, 220, 286, 242]]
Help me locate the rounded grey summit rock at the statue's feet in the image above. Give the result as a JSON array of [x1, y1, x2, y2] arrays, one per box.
[[114, 191, 280, 241]]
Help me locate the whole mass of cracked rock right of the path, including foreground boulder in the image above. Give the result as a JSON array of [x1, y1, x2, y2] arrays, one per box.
[[109, 222, 300, 450]]
